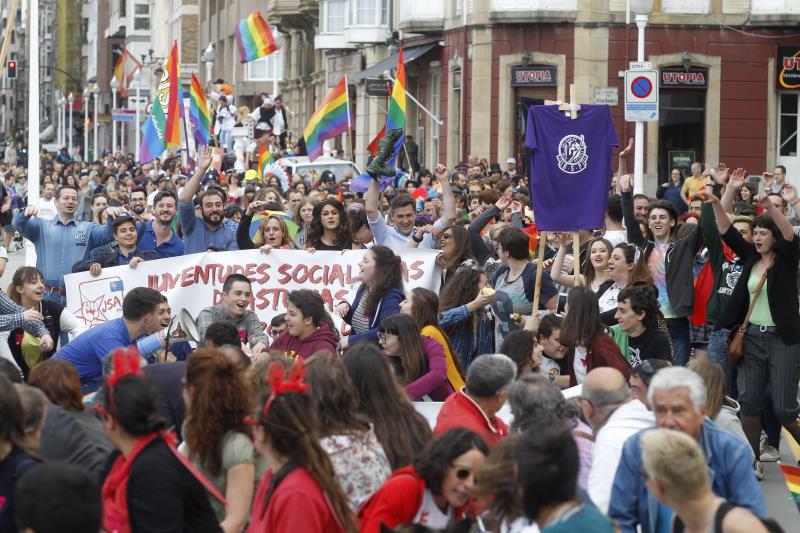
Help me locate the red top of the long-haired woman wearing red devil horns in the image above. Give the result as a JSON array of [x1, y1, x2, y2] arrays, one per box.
[[247, 467, 344, 533]]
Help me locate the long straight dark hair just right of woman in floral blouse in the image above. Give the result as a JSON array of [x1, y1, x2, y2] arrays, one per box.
[[342, 343, 433, 470]]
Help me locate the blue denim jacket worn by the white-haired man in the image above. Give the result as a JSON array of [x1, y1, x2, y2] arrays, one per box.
[[608, 418, 766, 533]]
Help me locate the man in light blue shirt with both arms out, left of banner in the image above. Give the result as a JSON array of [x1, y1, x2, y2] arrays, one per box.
[[13, 185, 117, 305]]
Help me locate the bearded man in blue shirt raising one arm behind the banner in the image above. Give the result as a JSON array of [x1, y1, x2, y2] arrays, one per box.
[[178, 147, 239, 254]]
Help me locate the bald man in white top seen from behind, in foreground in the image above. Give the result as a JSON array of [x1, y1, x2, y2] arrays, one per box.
[[581, 367, 656, 513]]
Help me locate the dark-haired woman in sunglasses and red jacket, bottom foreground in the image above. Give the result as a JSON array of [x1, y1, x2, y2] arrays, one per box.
[[358, 428, 489, 533]]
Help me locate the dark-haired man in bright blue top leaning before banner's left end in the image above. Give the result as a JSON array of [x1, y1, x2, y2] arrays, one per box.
[[53, 287, 163, 394]]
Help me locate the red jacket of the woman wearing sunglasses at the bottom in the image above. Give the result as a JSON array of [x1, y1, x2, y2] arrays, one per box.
[[358, 466, 467, 533]]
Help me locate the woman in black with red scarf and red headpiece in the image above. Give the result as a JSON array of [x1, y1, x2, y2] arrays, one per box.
[[95, 348, 224, 533]]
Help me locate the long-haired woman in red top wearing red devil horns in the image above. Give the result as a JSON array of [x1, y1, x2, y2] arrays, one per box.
[[247, 362, 357, 533]]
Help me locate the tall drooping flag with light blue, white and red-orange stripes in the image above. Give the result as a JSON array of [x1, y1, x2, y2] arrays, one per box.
[[139, 41, 181, 163]]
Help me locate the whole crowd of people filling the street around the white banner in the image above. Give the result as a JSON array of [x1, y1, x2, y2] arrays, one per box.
[[0, 100, 800, 533]]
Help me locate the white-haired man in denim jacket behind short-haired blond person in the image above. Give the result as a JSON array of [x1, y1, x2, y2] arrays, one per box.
[[608, 367, 765, 533]]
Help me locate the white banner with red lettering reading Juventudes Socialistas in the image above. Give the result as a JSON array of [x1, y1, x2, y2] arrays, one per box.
[[64, 248, 441, 329]]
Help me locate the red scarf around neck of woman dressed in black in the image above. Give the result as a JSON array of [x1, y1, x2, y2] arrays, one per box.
[[101, 431, 227, 533]]
